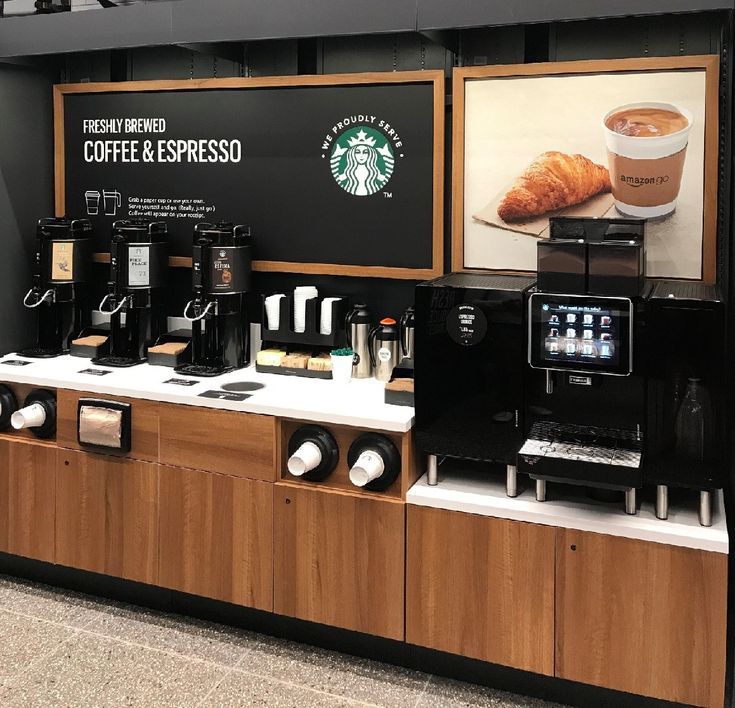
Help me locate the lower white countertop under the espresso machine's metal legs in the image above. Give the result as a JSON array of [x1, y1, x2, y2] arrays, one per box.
[[406, 467, 729, 553]]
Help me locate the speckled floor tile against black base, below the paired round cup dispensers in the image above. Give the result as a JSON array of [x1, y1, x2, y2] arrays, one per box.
[[238, 634, 429, 706]]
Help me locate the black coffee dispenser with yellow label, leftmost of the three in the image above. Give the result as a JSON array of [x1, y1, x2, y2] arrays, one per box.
[[20, 218, 92, 358]]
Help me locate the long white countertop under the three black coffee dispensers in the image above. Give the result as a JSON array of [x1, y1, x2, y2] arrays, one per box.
[[0, 354, 414, 433]]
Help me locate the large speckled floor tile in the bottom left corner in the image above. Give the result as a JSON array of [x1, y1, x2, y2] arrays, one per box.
[[0, 632, 227, 708]]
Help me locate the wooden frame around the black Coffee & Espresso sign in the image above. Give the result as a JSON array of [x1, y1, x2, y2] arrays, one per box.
[[54, 70, 444, 280]]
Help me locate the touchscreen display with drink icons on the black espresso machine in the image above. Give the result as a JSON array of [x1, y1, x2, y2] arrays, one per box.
[[530, 294, 631, 374]]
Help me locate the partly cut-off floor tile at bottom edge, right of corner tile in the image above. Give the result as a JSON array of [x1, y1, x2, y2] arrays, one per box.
[[202, 671, 364, 708]]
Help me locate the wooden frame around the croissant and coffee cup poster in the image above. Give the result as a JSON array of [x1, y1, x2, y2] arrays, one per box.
[[452, 55, 720, 283]]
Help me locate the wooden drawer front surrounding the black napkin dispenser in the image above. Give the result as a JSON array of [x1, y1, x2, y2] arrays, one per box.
[[56, 389, 160, 462]]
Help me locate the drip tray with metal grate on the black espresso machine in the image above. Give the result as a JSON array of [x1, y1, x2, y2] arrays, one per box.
[[518, 421, 643, 489]]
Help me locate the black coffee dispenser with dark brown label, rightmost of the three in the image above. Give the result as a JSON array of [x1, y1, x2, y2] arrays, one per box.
[[175, 222, 253, 376]]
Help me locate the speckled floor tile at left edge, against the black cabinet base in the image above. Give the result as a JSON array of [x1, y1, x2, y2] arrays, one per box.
[[0, 575, 105, 627]]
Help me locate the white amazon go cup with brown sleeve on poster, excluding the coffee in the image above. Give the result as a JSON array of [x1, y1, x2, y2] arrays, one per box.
[[602, 101, 694, 219]]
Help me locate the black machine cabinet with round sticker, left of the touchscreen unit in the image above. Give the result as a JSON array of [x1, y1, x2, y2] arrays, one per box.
[[414, 273, 534, 497]]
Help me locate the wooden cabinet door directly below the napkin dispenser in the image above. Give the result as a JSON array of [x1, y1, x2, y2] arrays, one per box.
[[56, 450, 158, 585]]
